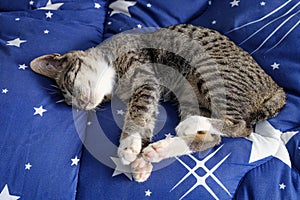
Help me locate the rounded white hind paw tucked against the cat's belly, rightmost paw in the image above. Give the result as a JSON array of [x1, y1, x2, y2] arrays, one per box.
[[175, 116, 213, 136]]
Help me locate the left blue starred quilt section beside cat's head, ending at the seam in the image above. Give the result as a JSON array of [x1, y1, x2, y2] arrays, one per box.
[[0, 1, 106, 200]]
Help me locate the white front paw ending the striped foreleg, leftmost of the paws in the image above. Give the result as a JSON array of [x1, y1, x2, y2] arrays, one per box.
[[118, 134, 142, 165]]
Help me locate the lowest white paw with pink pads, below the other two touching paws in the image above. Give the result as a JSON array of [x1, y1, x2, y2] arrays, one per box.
[[131, 157, 153, 182]]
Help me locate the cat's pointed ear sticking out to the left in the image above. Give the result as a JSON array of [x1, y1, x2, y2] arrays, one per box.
[[30, 53, 65, 79]]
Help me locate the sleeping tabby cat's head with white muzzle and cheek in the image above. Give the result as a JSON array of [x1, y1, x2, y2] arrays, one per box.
[[30, 51, 115, 110]]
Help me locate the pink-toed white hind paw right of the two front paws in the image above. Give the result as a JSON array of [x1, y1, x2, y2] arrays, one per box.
[[142, 139, 170, 162]]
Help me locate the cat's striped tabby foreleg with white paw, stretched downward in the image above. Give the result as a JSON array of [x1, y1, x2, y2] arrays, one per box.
[[118, 70, 160, 165]]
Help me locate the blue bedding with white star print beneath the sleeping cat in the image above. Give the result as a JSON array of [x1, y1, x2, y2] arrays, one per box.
[[0, 0, 300, 200]]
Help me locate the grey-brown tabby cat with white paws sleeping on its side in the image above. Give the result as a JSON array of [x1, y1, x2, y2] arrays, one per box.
[[30, 24, 285, 182]]
